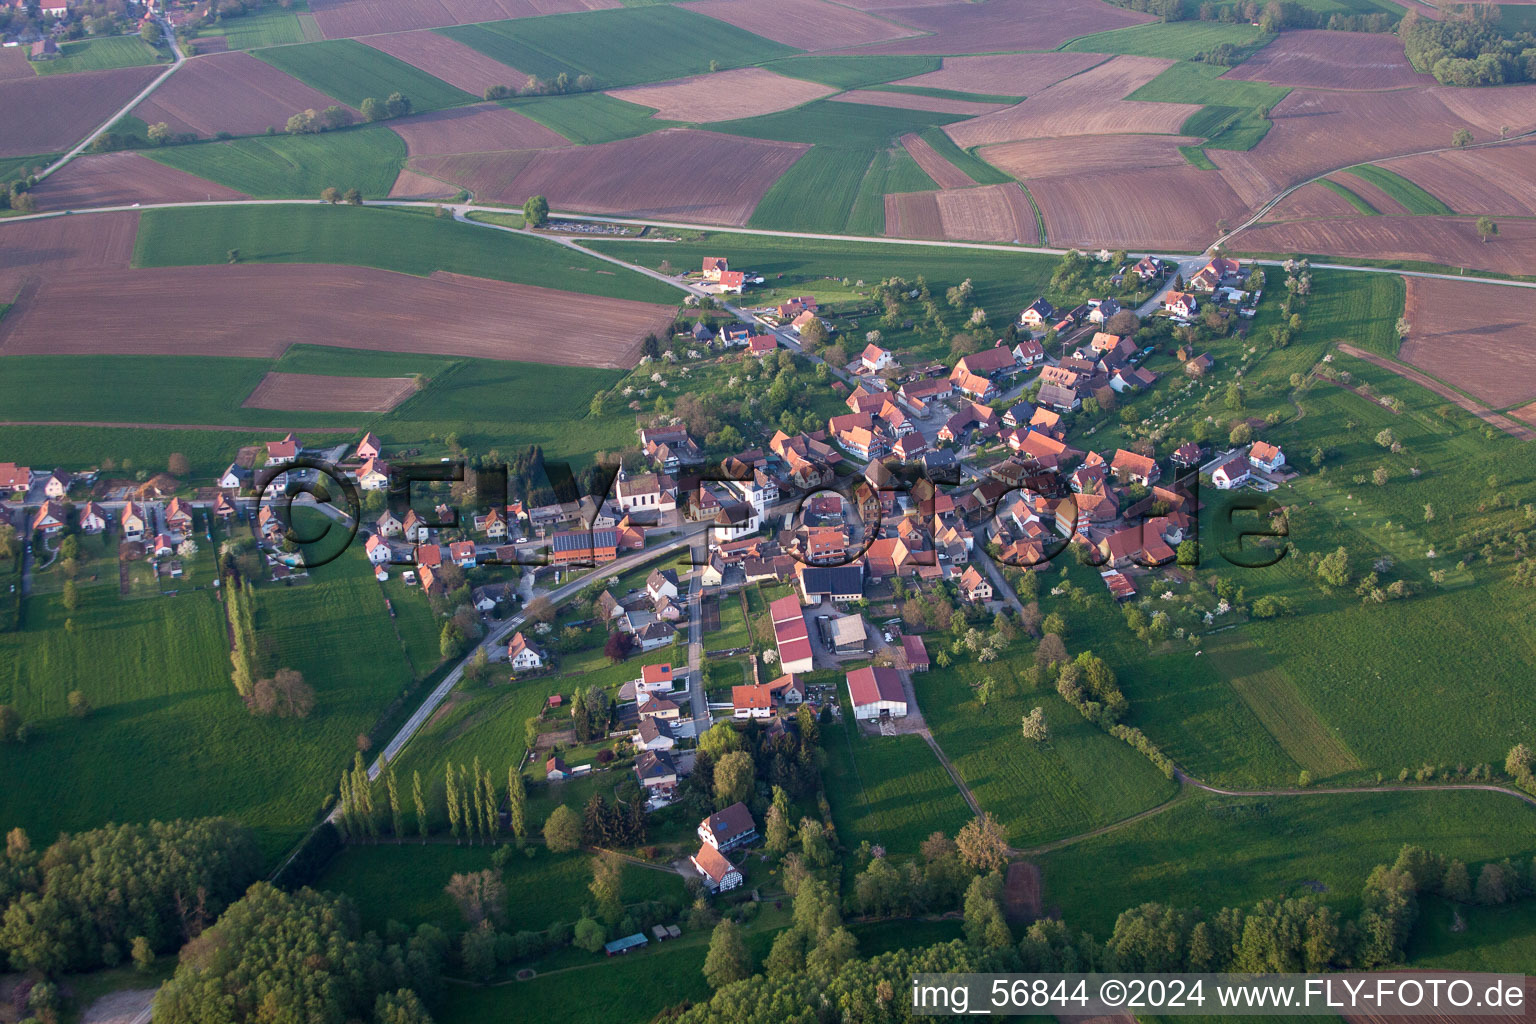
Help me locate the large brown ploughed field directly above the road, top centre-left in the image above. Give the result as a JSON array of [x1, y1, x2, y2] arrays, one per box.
[[412, 129, 809, 226]]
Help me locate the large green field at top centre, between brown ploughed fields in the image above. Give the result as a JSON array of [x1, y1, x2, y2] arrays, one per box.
[[439, 5, 796, 89]]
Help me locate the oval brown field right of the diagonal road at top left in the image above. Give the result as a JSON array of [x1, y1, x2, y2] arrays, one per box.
[[134, 52, 356, 137]]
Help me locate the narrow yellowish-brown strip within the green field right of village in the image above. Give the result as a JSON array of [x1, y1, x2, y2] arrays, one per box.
[[1206, 634, 1361, 775]]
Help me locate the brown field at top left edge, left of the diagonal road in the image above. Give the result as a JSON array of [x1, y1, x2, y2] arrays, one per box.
[[0, 66, 164, 157]]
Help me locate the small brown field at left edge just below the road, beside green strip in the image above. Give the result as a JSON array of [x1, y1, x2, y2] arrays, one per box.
[[0, 213, 138, 297]]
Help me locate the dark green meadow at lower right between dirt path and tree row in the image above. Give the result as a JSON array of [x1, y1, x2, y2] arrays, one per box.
[[1040, 792, 1536, 935]]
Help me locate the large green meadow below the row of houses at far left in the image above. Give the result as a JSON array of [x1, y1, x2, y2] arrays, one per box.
[[0, 543, 410, 858]]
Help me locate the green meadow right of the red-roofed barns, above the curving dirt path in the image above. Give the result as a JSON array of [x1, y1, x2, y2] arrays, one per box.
[[915, 654, 1175, 846]]
